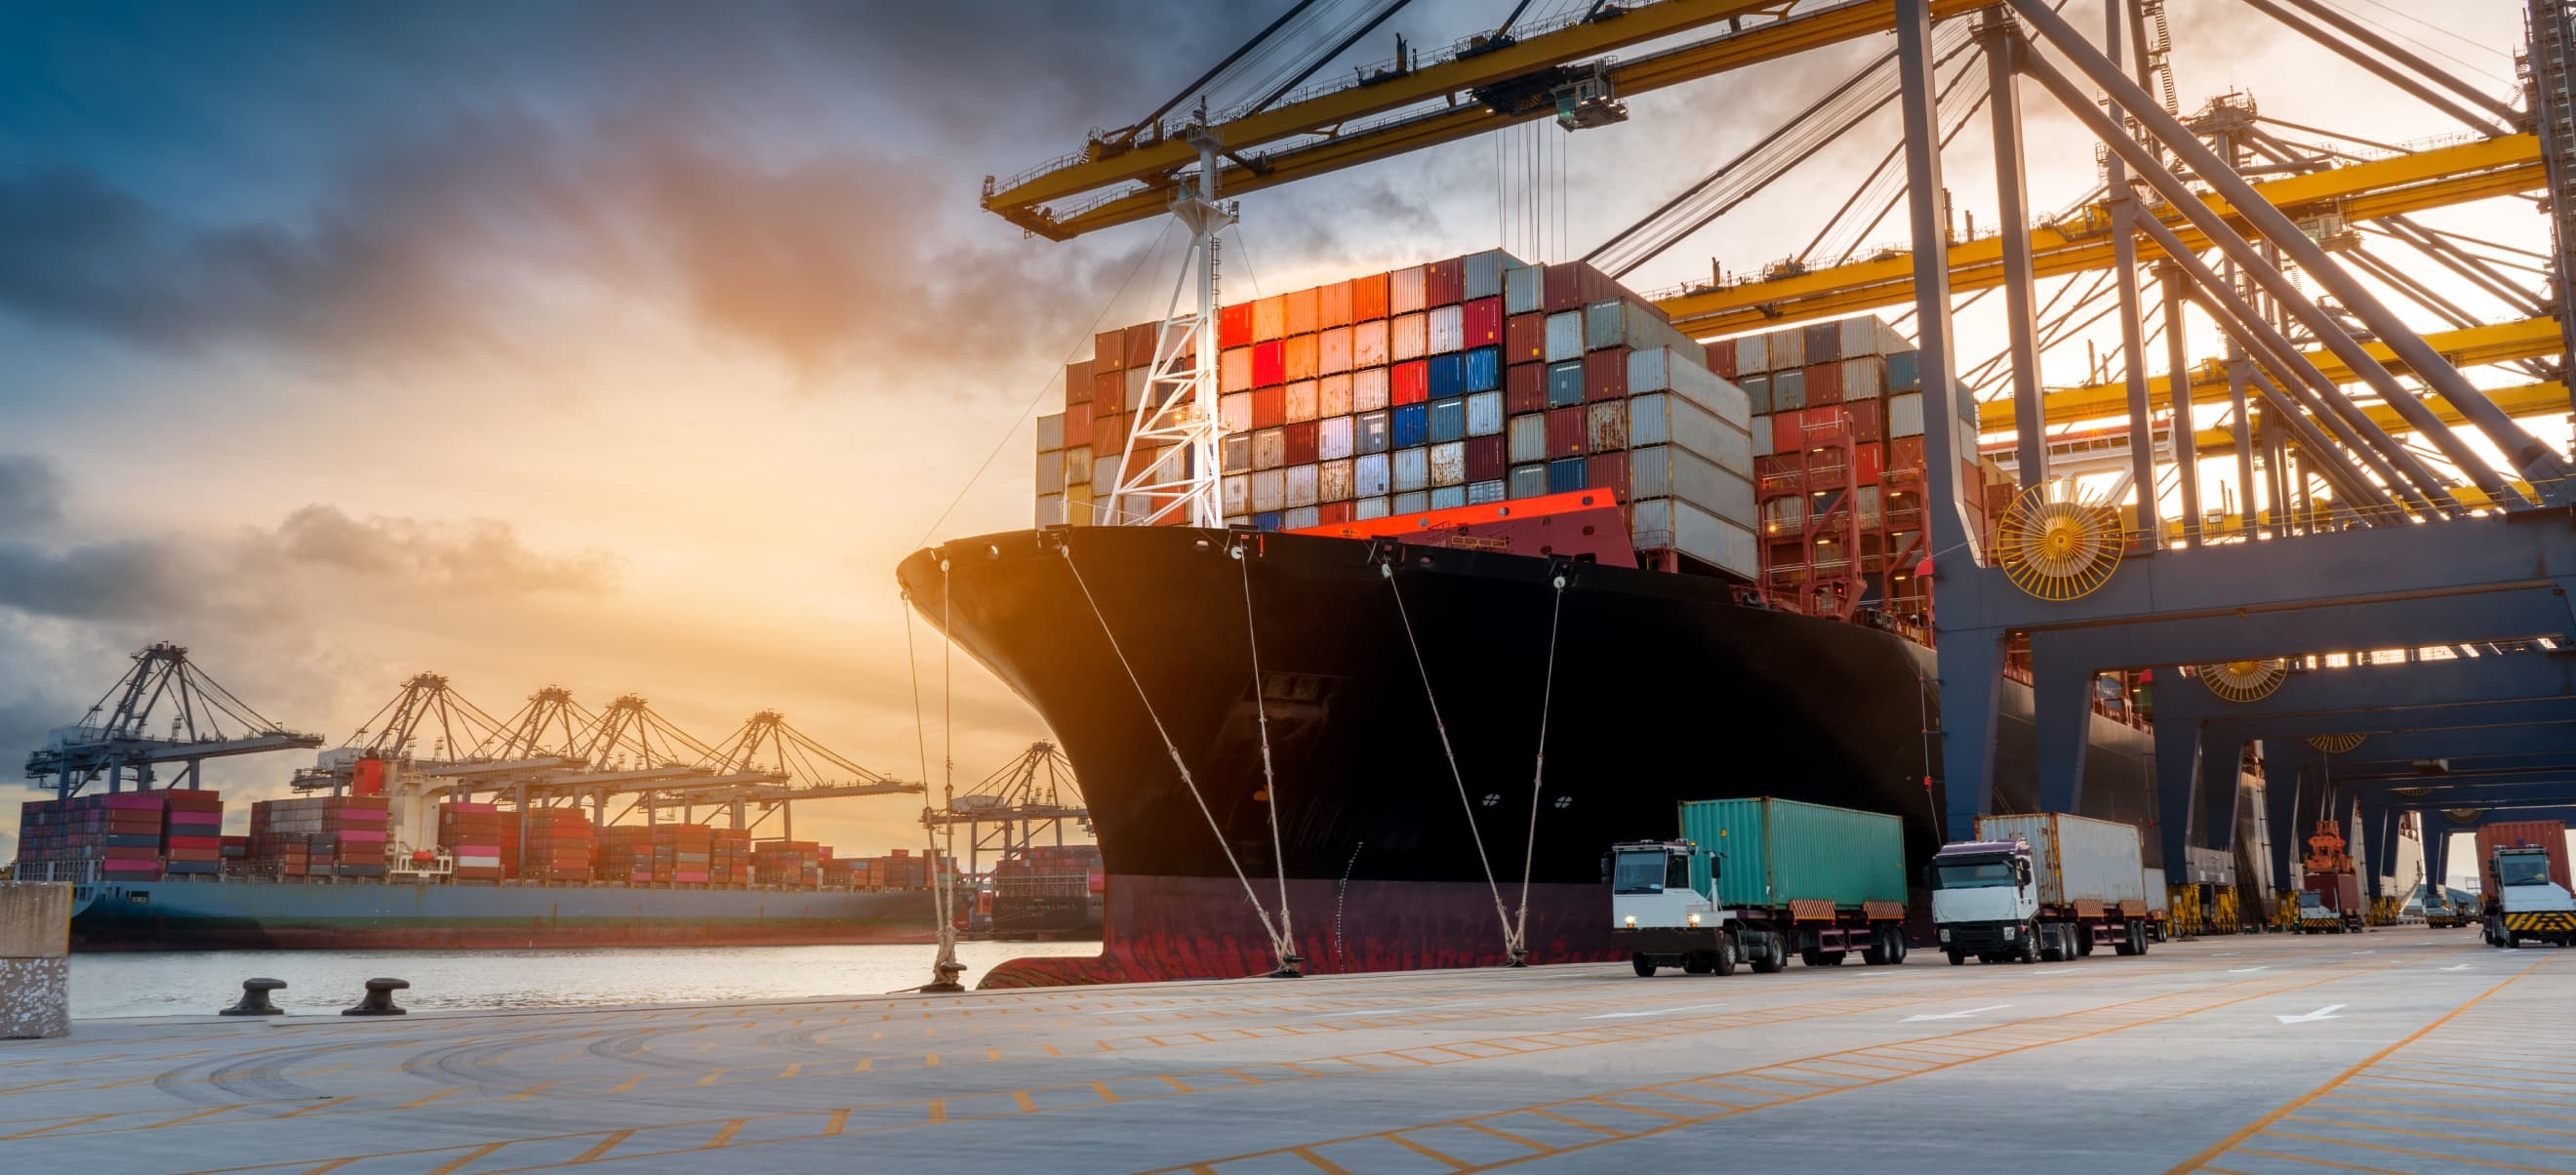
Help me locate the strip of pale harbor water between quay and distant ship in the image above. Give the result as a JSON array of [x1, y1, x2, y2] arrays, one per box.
[[72, 943, 1100, 1018]]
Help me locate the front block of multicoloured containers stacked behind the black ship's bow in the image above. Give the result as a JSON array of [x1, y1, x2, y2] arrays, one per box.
[[1038, 250, 1759, 577]]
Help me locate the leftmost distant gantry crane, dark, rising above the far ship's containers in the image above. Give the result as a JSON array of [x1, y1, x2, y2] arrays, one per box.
[[25, 641, 322, 799]]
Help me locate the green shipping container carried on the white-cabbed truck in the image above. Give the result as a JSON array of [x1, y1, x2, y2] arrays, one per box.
[[1682, 799, 1907, 907]]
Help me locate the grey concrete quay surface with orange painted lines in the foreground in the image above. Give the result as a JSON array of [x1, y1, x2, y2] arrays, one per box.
[[0, 928, 2576, 1175]]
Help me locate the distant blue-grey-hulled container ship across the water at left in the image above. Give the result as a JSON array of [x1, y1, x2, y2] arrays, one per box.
[[16, 789, 953, 951]]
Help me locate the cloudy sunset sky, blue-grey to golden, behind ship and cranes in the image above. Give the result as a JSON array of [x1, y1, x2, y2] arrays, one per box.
[[0, 0, 2534, 858]]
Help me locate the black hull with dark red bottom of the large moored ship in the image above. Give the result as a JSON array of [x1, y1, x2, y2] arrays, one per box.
[[899, 528, 2156, 987]]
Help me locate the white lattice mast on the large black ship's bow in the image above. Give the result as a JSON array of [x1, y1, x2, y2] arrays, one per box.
[[1098, 111, 1234, 528]]
